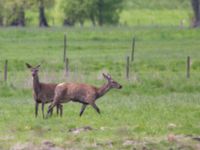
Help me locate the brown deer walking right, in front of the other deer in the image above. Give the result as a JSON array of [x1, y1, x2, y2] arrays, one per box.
[[47, 74, 122, 117]]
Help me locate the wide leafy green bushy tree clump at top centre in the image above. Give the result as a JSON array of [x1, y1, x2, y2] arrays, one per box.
[[60, 0, 122, 26]]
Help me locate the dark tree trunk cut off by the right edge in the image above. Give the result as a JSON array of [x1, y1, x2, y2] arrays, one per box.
[[191, 0, 200, 27]]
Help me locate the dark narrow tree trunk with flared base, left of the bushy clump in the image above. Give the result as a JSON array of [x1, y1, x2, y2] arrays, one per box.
[[39, 0, 49, 27]]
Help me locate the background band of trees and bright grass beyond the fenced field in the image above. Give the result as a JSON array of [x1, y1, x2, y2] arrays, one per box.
[[0, 0, 193, 27]]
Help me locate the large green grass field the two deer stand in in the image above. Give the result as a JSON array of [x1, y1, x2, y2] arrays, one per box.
[[0, 26, 200, 149]]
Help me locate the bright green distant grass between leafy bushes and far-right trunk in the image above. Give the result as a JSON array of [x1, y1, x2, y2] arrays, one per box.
[[120, 9, 193, 26]]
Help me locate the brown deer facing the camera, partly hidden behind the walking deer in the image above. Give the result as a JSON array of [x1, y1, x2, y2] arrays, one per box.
[[26, 63, 62, 118]]
